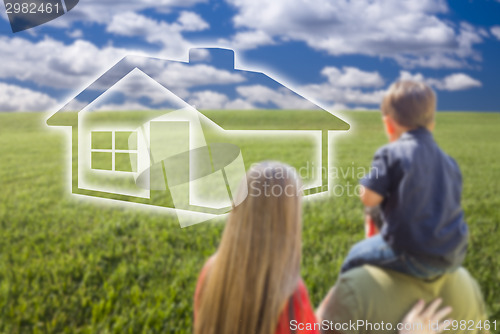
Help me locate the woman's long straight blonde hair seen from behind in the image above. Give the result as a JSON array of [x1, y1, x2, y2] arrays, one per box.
[[194, 162, 302, 334]]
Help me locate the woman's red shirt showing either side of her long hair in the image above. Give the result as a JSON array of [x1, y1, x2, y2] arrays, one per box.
[[194, 257, 319, 334]]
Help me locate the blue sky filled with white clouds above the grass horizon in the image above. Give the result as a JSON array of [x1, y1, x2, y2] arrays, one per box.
[[0, 0, 500, 111]]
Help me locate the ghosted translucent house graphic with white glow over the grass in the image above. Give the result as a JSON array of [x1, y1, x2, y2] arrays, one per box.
[[47, 49, 349, 226]]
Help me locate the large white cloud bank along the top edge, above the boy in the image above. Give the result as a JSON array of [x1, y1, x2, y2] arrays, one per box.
[[226, 0, 484, 67]]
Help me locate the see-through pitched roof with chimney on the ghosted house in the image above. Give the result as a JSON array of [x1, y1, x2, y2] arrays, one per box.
[[47, 49, 349, 130]]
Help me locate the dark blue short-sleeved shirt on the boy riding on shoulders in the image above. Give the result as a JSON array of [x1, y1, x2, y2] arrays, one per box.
[[361, 128, 468, 266]]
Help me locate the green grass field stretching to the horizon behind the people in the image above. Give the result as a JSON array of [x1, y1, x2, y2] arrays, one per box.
[[0, 112, 500, 334]]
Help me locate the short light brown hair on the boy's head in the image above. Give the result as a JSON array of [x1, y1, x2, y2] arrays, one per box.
[[380, 80, 436, 129]]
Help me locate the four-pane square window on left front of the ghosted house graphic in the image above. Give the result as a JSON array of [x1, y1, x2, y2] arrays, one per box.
[[90, 131, 137, 172]]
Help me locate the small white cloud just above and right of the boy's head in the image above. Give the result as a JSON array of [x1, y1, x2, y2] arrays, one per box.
[[400, 71, 482, 91]]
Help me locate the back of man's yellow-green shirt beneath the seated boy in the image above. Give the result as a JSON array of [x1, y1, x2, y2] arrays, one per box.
[[318, 265, 486, 333]]
